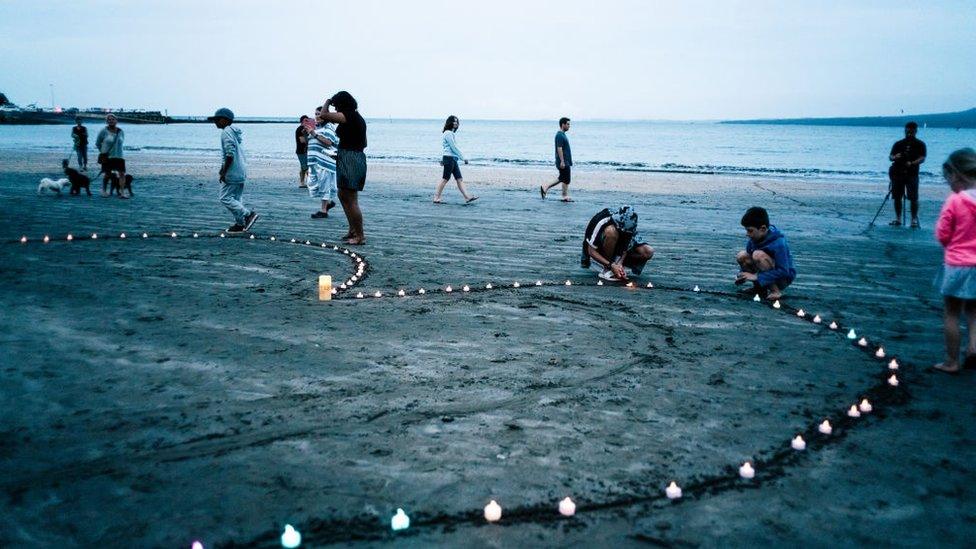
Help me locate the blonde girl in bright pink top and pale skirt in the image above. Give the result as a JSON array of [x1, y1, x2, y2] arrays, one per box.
[[935, 148, 976, 374]]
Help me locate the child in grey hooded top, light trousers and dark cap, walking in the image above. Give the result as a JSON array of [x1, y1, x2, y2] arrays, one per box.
[[208, 108, 258, 233]]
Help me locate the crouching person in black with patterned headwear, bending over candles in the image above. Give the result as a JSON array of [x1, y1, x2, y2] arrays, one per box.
[[580, 206, 654, 281]]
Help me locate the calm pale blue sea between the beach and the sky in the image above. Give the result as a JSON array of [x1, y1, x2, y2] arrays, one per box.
[[0, 119, 976, 183]]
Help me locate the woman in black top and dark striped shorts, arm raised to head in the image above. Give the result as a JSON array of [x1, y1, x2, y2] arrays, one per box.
[[321, 91, 366, 245]]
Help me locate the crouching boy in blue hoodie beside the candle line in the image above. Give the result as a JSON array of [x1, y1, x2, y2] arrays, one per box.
[[735, 206, 796, 301]]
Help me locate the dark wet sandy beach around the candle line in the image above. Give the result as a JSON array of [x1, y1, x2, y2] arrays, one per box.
[[0, 148, 976, 547]]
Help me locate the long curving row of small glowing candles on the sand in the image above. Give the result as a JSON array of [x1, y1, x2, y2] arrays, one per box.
[[11, 232, 899, 549]]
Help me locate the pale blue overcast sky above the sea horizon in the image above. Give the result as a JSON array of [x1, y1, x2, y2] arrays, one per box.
[[0, 0, 976, 120]]
